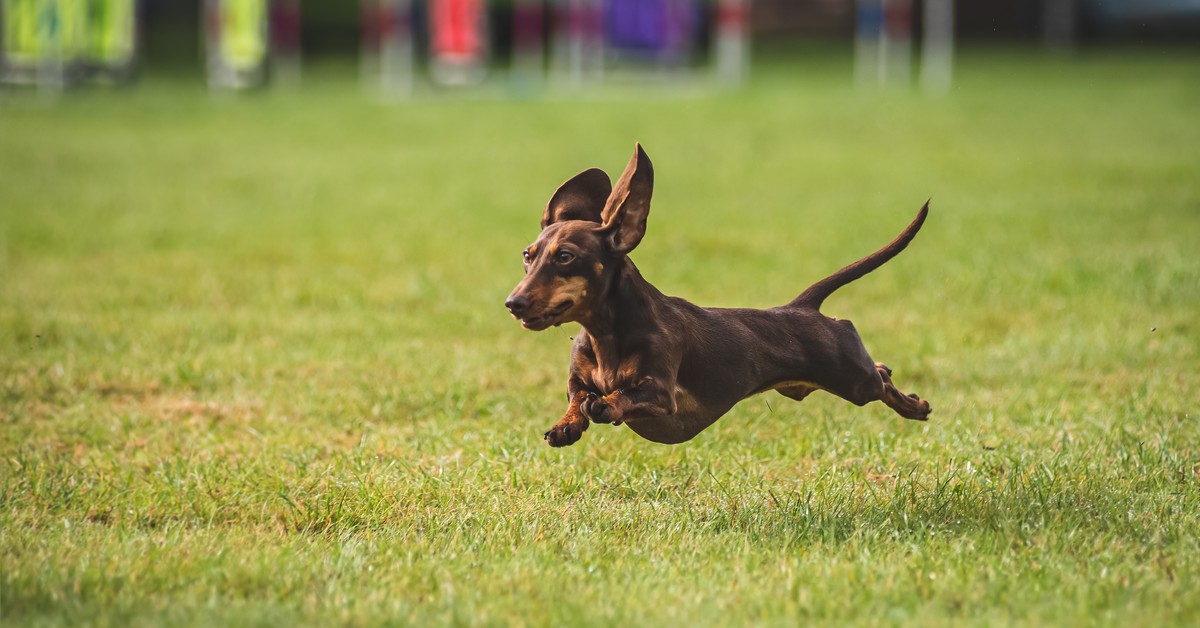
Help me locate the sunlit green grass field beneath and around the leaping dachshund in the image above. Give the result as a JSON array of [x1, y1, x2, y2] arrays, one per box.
[[0, 50, 1200, 626]]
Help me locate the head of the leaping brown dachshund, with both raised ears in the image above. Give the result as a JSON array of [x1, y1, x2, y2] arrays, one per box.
[[504, 144, 654, 331]]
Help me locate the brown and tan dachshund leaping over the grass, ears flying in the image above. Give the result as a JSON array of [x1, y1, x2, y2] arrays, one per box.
[[505, 144, 930, 447]]
